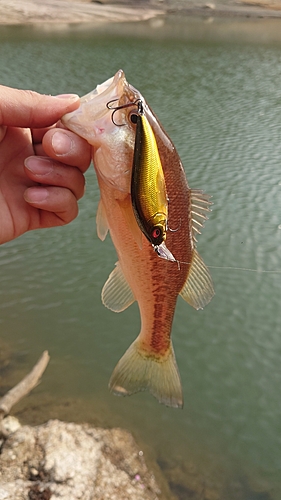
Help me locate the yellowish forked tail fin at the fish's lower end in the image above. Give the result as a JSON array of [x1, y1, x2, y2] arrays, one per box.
[[109, 338, 183, 408]]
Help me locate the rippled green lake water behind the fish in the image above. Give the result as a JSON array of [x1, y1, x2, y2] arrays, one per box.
[[0, 15, 281, 500]]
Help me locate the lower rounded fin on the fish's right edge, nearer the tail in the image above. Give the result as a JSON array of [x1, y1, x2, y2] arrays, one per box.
[[180, 249, 215, 309]]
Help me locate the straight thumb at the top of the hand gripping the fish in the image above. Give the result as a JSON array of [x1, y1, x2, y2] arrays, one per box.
[[0, 85, 79, 128]]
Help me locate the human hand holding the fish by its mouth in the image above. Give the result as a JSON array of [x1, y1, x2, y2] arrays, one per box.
[[0, 85, 91, 244]]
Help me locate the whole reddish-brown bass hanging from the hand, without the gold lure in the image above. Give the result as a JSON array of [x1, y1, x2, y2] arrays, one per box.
[[62, 70, 214, 408]]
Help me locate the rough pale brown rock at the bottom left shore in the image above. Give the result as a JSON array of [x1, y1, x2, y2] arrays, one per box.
[[0, 420, 160, 500]]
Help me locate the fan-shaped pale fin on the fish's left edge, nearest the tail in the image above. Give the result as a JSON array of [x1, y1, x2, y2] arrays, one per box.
[[101, 262, 135, 312]]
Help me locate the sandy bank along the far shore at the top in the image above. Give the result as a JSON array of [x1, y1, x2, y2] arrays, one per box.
[[0, 0, 281, 24]]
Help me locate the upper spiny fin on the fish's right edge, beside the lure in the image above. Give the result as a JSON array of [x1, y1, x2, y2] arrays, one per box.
[[190, 189, 212, 242]]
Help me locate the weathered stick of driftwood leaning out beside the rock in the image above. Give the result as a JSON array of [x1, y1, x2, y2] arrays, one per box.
[[0, 351, 50, 424]]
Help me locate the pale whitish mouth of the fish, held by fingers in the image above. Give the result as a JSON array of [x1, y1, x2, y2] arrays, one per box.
[[61, 69, 132, 144]]
